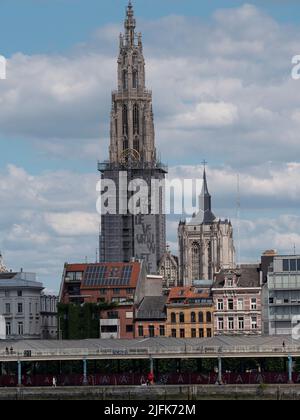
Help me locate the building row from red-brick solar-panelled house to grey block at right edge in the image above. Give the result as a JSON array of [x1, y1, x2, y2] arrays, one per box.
[[60, 251, 300, 339]]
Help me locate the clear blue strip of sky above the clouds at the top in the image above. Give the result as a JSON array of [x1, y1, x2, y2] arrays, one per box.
[[0, 0, 300, 56]]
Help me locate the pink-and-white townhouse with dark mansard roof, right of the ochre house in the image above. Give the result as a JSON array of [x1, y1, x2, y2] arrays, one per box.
[[212, 265, 262, 335]]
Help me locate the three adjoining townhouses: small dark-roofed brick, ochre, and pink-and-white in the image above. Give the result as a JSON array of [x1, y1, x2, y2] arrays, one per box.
[[135, 265, 263, 338]]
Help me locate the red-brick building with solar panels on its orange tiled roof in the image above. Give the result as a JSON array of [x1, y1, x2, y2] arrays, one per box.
[[60, 262, 146, 339]]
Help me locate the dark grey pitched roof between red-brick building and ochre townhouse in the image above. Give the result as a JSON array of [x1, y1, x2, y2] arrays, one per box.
[[136, 296, 167, 321]]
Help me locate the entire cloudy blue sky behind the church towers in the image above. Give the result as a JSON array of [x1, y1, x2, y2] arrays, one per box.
[[0, 0, 300, 291]]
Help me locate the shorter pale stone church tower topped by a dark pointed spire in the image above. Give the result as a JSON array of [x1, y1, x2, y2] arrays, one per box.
[[178, 169, 235, 286]]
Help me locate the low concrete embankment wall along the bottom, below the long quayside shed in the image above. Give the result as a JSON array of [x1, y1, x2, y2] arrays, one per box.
[[0, 385, 300, 401]]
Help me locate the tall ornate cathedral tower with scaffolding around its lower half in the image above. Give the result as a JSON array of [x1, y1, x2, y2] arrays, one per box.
[[99, 2, 167, 274]]
